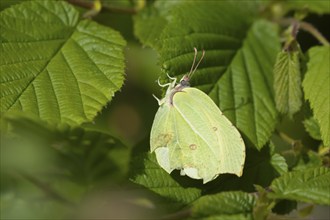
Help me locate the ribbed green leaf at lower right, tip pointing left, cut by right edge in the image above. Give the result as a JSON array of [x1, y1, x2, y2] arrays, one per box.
[[269, 167, 330, 205]]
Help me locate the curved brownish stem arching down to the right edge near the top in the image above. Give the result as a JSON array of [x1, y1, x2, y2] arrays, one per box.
[[280, 18, 330, 46]]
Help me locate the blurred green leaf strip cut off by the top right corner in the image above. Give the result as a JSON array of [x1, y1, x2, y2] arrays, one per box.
[[283, 0, 330, 14]]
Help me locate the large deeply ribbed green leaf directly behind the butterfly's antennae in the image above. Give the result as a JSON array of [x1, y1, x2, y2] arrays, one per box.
[[138, 1, 280, 149]]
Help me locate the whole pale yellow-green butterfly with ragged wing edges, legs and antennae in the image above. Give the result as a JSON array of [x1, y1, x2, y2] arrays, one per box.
[[150, 48, 245, 183]]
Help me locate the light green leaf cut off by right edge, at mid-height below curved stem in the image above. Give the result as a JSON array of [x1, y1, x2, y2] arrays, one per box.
[[303, 46, 330, 146]]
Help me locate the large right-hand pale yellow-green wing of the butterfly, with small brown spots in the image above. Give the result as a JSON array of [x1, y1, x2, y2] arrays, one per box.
[[173, 88, 245, 183]]
